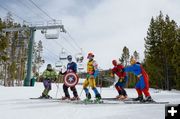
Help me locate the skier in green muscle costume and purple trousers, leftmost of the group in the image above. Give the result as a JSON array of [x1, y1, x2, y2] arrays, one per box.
[[40, 64, 57, 98]]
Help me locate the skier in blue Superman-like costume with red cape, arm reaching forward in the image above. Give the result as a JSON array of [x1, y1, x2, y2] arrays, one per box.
[[123, 57, 153, 102]]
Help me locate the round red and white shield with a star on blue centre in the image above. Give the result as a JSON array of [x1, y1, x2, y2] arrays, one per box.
[[64, 72, 79, 87]]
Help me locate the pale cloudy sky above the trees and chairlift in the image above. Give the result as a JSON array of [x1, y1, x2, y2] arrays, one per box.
[[0, 0, 180, 69]]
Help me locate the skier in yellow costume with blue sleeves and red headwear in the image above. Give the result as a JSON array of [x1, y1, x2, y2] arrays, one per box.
[[83, 53, 101, 101]]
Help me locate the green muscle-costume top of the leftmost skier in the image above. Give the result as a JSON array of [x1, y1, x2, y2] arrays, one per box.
[[43, 69, 58, 80]]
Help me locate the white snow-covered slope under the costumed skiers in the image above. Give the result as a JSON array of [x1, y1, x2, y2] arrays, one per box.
[[0, 83, 180, 119]]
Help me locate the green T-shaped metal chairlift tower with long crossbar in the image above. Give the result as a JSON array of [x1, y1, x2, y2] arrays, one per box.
[[3, 20, 66, 86]]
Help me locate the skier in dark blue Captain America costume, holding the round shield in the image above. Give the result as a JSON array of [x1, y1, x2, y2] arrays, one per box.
[[60, 55, 80, 100]]
